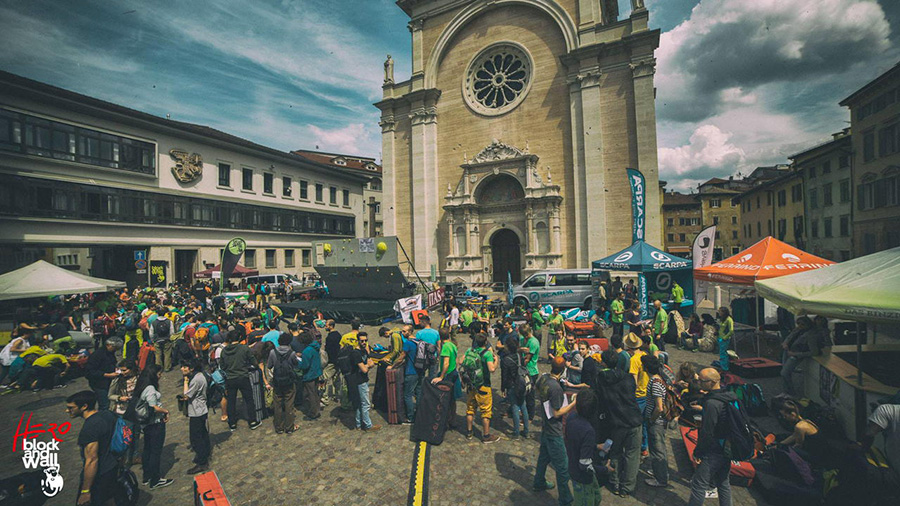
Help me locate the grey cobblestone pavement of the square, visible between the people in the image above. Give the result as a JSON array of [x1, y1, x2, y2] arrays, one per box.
[[0, 320, 774, 506]]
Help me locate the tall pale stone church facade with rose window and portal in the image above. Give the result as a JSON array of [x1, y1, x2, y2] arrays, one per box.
[[375, 0, 661, 283]]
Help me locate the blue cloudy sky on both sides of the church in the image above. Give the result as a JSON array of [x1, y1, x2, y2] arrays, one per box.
[[0, 0, 900, 189]]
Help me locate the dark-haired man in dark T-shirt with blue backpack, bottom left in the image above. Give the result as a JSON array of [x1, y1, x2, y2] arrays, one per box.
[[66, 390, 119, 506]]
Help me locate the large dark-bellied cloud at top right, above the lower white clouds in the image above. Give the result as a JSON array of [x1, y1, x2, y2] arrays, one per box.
[[656, 0, 891, 121]]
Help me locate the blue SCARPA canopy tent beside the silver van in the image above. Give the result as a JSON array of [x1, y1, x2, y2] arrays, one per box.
[[591, 240, 694, 318]]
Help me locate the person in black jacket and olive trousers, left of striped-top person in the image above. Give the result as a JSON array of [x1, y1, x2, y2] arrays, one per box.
[[595, 349, 642, 497]]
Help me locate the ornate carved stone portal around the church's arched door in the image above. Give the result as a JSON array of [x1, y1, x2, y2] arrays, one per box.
[[443, 140, 563, 283]]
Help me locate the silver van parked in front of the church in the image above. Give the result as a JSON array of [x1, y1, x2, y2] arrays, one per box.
[[513, 269, 609, 309]]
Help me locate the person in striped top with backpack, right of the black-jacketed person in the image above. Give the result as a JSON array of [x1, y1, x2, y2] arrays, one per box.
[[641, 355, 669, 488]]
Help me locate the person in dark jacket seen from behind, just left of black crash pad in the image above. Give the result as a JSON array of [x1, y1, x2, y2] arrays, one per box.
[[219, 330, 261, 432]]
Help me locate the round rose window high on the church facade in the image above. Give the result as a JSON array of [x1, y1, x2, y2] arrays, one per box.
[[463, 42, 533, 116]]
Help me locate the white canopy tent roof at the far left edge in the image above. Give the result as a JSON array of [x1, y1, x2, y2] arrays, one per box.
[[0, 260, 125, 300]]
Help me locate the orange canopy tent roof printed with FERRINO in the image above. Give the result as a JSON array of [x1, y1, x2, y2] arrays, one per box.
[[694, 236, 834, 285]]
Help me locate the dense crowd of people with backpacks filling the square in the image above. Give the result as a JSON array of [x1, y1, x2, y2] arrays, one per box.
[[0, 283, 898, 506]]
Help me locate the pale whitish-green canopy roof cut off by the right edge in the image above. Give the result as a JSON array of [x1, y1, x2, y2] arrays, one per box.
[[756, 248, 900, 325]]
